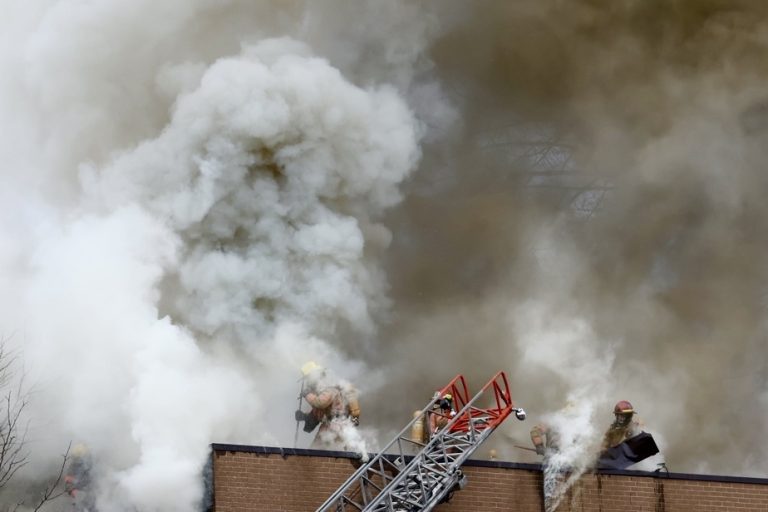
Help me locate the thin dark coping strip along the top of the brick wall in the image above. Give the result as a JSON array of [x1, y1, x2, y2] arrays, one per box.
[[211, 443, 768, 485]]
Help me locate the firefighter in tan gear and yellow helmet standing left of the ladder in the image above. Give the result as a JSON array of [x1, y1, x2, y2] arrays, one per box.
[[296, 361, 361, 451]]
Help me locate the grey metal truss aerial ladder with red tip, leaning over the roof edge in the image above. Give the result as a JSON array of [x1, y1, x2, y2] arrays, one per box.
[[317, 372, 517, 512]]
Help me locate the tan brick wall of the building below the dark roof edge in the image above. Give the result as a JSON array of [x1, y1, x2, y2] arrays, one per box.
[[212, 444, 768, 512]]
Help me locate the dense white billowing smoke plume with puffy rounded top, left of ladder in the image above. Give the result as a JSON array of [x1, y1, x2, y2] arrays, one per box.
[[3, 3, 420, 504]]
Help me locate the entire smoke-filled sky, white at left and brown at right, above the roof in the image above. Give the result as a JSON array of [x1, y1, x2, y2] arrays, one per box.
[[0, 0, 768, 511]]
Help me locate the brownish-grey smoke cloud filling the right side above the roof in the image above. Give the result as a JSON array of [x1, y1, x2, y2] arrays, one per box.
[[372, 1, 768, 475]]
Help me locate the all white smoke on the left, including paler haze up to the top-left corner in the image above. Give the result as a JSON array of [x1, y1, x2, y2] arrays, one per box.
[[0, 2, 421, 511]]
